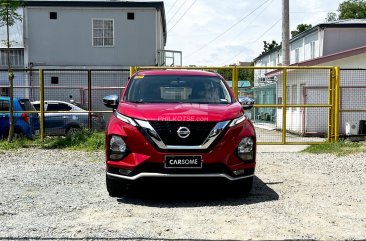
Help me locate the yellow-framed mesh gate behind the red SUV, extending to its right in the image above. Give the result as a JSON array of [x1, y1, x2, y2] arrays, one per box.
[[130, 66, 340, 145]]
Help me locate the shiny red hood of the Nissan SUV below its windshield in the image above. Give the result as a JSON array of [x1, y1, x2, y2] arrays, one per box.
[[117, 102, 243, 122]]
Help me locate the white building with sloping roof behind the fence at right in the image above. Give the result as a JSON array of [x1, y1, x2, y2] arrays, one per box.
[[254, 20, 366, 135]]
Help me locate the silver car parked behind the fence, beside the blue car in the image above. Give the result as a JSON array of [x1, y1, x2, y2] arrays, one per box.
[[32, 100, 105, 135]]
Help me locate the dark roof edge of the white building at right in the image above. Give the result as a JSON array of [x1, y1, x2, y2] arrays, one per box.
[[253, 19, 366, 62]]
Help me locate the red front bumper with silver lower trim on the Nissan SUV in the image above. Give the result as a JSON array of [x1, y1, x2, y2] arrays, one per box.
[[106, 117, 256, 181]]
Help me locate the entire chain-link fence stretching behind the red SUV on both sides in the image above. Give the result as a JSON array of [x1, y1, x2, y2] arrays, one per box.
[[0, 66, 358, 144]]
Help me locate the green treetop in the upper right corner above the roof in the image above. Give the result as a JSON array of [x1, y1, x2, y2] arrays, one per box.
[[338, 0, 366, 19]]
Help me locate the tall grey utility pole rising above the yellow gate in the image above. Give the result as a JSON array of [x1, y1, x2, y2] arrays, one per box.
[[282, 0, 290, 66]]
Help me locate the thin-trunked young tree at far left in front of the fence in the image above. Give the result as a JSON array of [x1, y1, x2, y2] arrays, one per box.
[[0, 0, 22, 142]]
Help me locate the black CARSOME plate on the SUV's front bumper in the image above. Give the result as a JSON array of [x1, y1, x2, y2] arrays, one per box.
[[165, 156, 202, 168]]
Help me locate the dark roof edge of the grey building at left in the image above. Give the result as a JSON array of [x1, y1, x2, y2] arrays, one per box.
[[24, 1, 167, 44]]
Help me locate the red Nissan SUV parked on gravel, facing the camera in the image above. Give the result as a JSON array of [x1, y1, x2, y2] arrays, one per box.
[[103, 70, 256, 196]]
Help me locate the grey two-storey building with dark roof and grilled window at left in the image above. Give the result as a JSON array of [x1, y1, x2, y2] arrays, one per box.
[[0, 1, 177, 106]]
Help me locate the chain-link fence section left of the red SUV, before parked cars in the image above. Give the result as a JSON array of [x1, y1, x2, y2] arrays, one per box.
[[0, 69, 130, 138]]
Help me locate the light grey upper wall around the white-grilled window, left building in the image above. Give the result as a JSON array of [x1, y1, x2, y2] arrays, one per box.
[[24, 7, 160, 66]]
